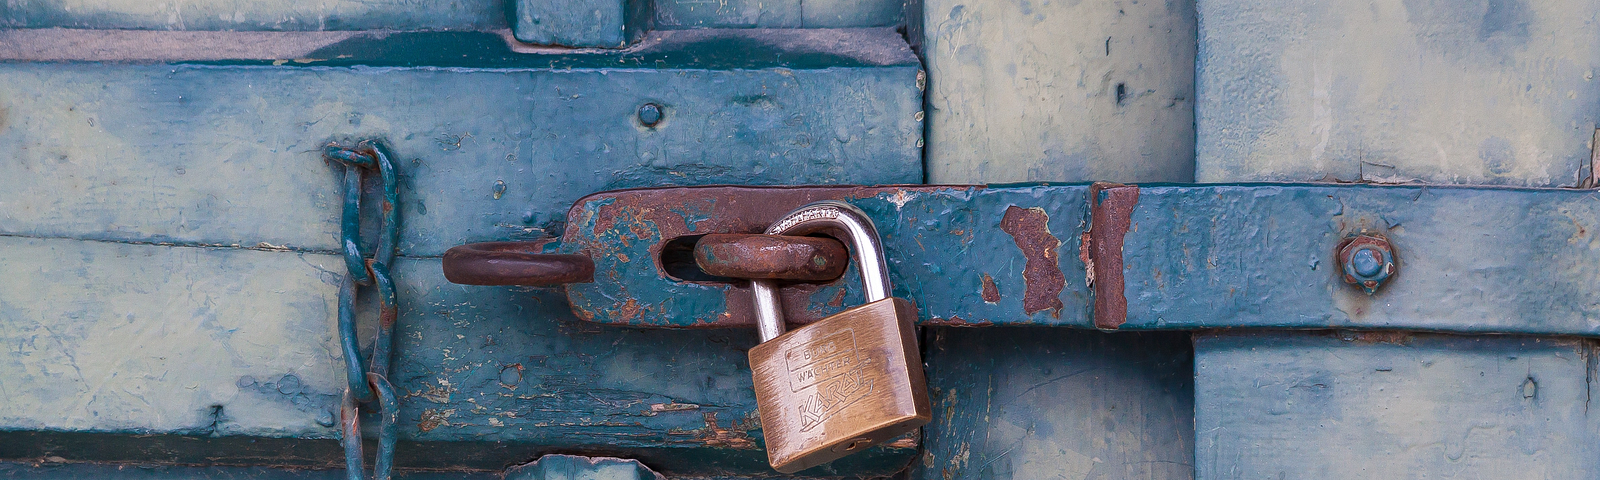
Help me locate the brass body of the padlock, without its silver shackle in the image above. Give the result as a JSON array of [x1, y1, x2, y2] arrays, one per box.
[[750, 298, 933, 474]]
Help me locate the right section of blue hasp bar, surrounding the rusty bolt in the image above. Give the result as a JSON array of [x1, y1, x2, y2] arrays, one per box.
[[1122, 186, 1600, 336]]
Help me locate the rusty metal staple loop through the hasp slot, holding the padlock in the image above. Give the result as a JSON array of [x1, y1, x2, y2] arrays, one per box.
[[694, 234, 850, 282]]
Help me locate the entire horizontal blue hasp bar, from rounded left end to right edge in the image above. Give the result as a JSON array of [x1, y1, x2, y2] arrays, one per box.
[[562, 184, 1600, 336]]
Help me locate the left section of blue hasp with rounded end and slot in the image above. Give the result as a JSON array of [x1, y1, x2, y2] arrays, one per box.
[[562, 186, 1090, 328]]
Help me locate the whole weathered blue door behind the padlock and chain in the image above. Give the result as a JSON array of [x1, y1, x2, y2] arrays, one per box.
[[0, 0, 1600, 478]]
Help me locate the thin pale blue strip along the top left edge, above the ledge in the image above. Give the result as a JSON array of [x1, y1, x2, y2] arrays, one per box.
[[0, 0, 506, 30]]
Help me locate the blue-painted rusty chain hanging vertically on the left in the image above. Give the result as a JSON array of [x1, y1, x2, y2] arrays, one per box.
[[323, 141, 400, 480]]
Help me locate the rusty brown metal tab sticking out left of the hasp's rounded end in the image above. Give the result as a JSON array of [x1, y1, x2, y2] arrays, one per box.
[[443, 242, 595, 285]]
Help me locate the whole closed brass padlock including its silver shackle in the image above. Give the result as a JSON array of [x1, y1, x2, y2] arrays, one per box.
[[750, 202, 933, 474]]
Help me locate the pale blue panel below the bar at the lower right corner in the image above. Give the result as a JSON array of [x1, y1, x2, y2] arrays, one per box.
[[1195, 333, 1600, 480]]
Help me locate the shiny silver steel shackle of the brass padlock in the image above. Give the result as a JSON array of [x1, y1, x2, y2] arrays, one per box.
[[750, 200, 890, 342]]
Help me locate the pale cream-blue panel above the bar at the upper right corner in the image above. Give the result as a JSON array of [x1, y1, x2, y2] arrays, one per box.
[[1195, 0, 1600, 186]]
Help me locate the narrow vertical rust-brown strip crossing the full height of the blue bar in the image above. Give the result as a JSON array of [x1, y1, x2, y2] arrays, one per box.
[[1080, 182, 1139, 330]]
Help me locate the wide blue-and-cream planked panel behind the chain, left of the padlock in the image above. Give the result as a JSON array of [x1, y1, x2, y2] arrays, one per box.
[[0, 29, 922, 475]]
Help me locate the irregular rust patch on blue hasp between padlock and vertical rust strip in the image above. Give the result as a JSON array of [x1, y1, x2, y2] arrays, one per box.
[[997, 205, 1067, 318]]
